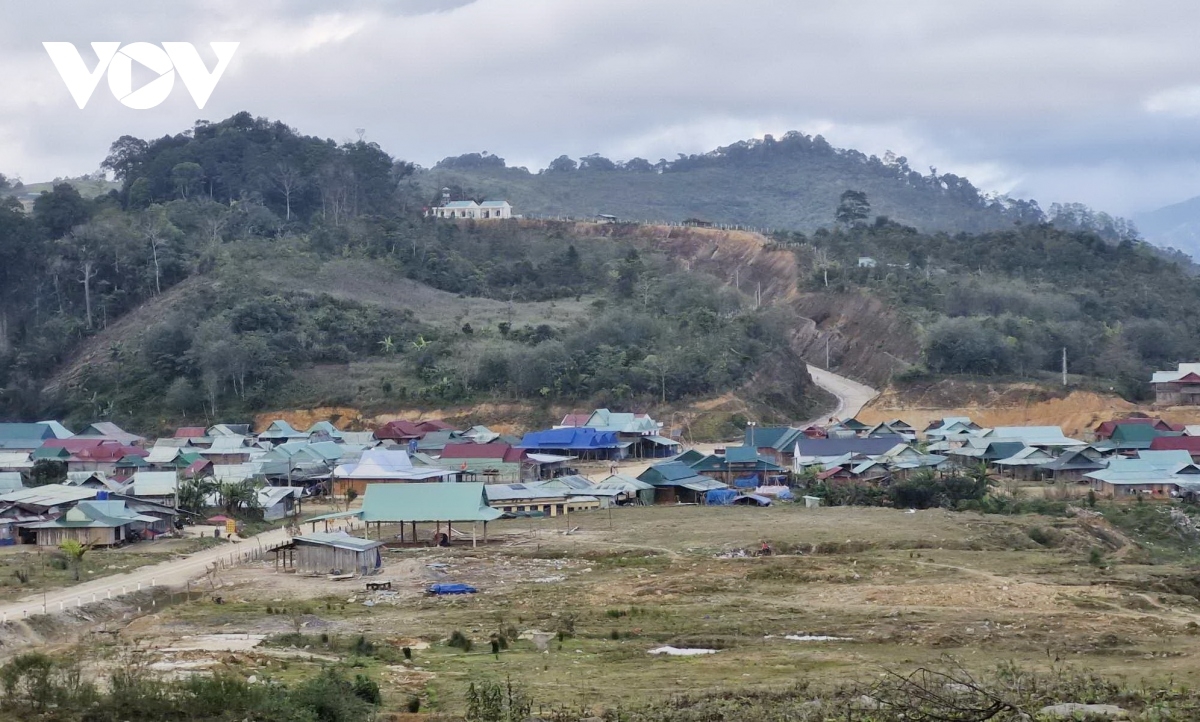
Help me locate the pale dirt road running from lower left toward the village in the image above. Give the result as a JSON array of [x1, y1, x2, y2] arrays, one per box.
[[0, 522, 352, 621]]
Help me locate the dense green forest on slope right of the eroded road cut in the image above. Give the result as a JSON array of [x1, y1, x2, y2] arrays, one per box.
[[776, 217, 1200, 399]]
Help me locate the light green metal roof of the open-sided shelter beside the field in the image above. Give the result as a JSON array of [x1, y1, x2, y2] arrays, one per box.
[[362, 482, 500, 522]]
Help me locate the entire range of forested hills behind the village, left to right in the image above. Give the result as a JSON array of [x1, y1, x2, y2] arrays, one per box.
[[0, 113, 1200, 433]]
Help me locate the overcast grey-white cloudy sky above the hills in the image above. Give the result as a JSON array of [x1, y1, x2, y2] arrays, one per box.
[[7, 0, 1200, 215]]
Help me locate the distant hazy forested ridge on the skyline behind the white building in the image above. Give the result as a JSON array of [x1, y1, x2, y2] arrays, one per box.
[[424, 131, 1136, 241]]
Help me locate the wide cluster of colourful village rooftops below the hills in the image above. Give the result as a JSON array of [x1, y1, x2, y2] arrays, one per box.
[[0, 395, 1200, 554]]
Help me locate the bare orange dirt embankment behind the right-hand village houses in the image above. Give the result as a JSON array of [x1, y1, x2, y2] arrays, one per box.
[[858, 379, 1200, 438]]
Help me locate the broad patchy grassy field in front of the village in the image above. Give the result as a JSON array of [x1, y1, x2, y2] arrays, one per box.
[[88, 505, 1200, 712]]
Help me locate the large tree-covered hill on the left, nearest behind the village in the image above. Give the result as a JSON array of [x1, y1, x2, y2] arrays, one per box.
[[0, 114, 794, 429]]
